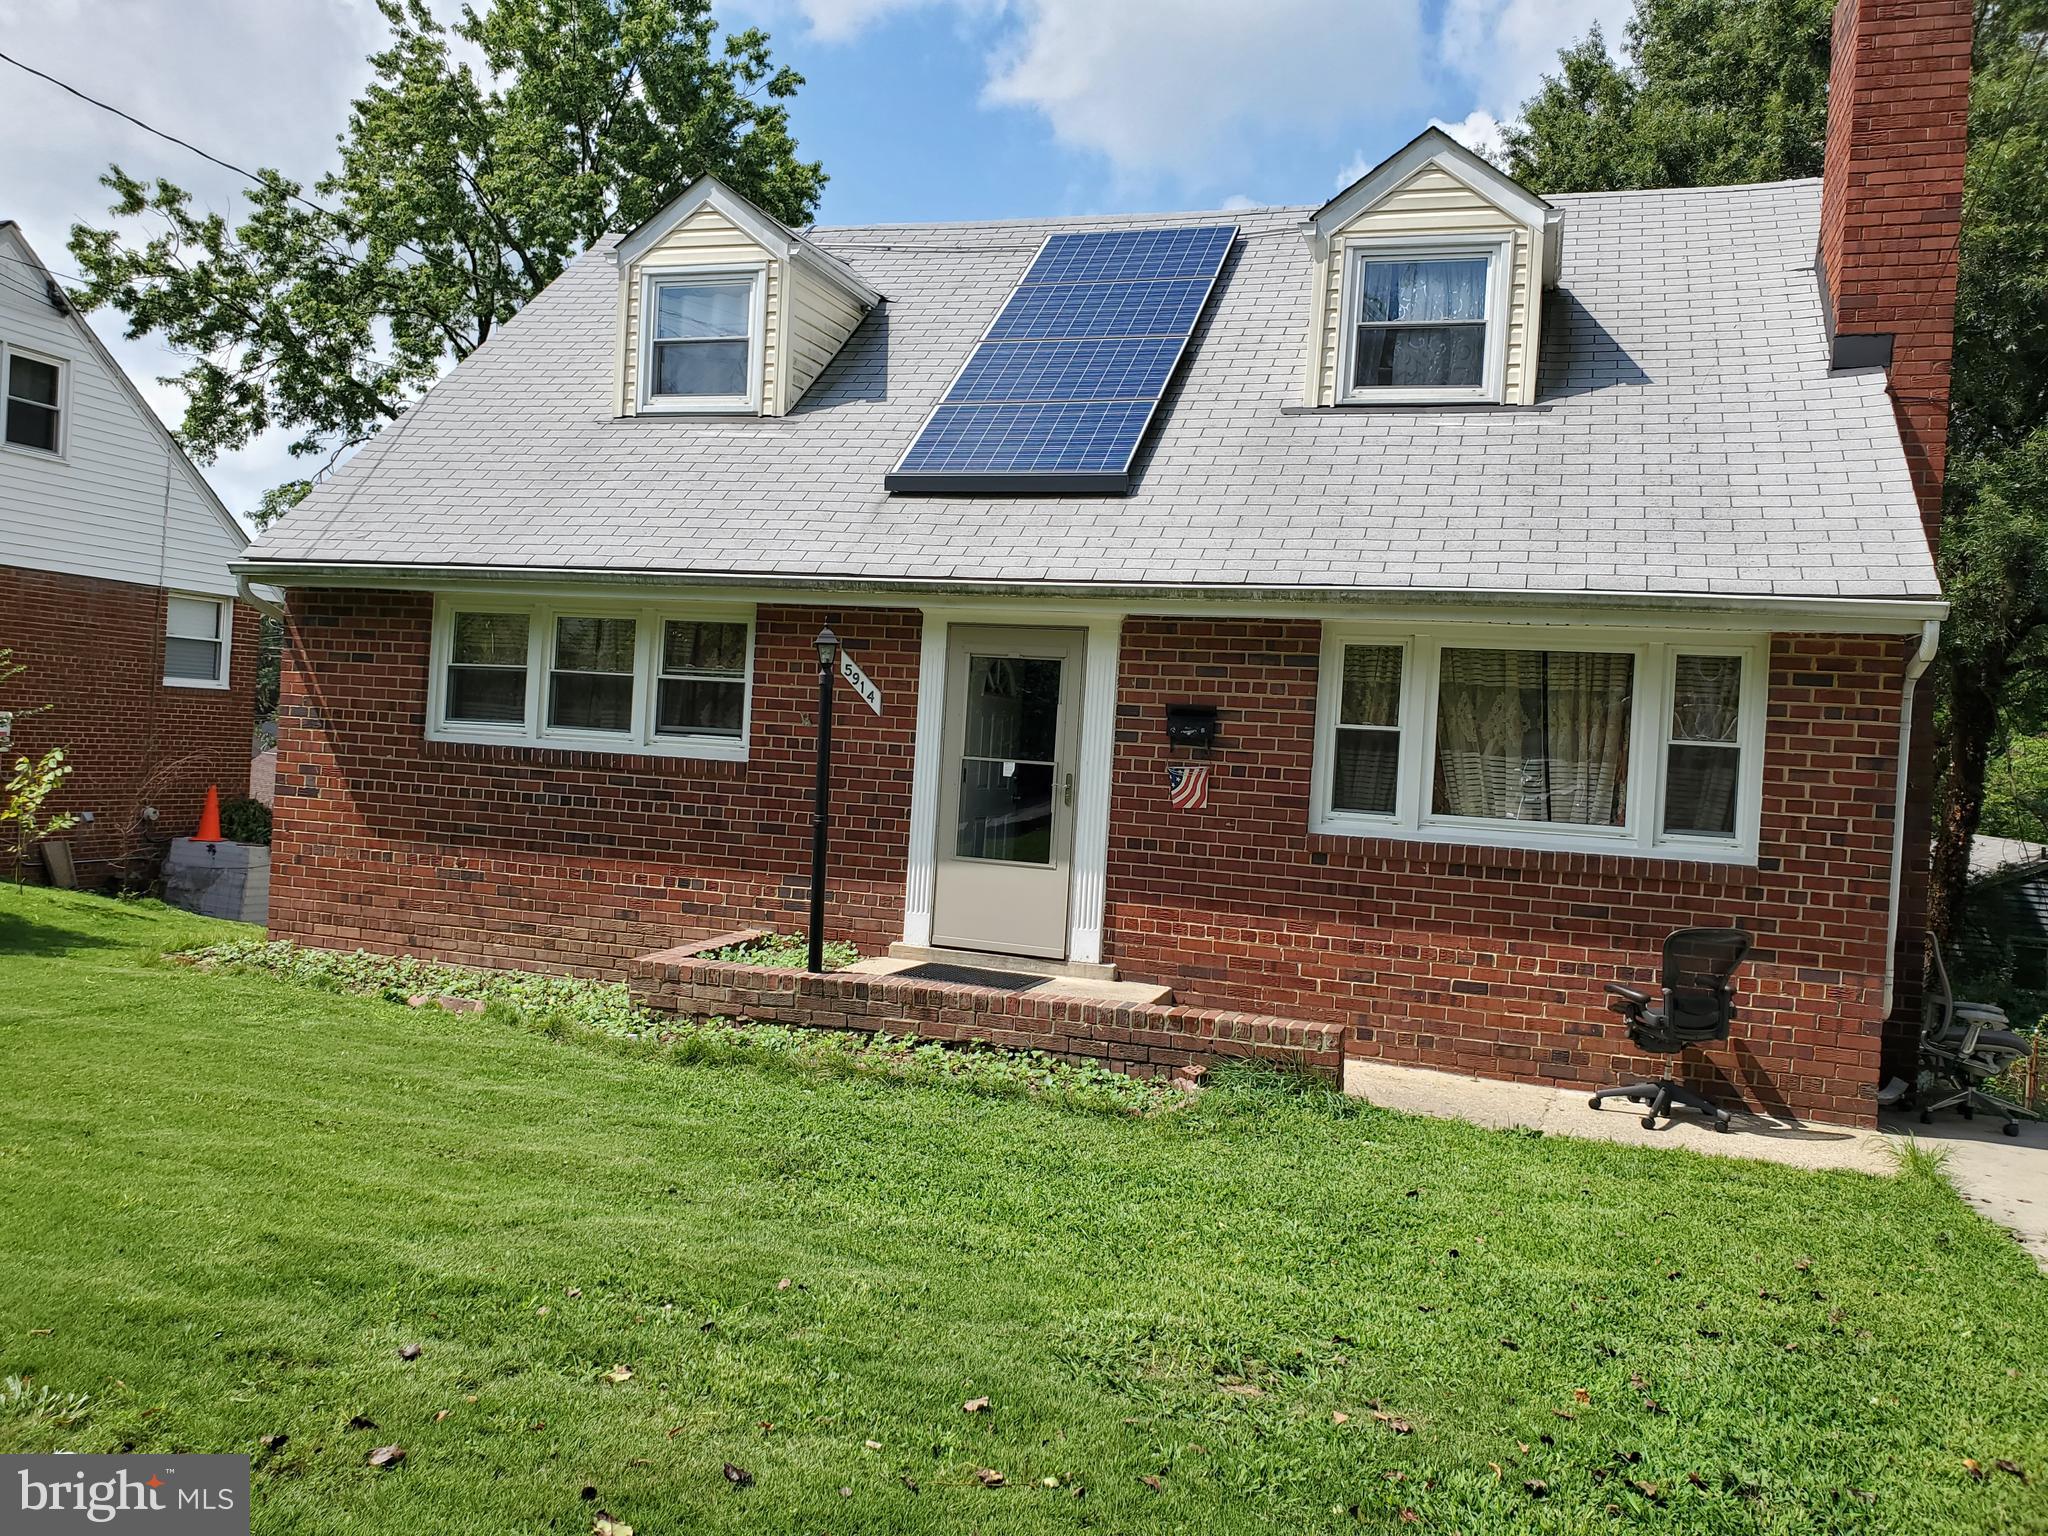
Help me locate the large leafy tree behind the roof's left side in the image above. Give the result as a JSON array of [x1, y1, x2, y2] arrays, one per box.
[[70, 0, 825, 520]]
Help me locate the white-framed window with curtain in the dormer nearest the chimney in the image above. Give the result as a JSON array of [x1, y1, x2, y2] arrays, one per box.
[[1343, 244, 1511, 401]]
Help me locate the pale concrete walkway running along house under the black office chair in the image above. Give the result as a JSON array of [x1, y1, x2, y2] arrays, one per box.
[[1343, 1059, 2048, 1266]]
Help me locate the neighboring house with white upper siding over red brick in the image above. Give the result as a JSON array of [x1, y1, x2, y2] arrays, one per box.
[[0, 221, 256, 885]]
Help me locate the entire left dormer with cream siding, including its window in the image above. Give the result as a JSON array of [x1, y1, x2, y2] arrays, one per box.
[[612, 176, 881, 416]]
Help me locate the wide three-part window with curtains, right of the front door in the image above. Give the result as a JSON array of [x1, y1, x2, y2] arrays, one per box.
[[1311, 625, 1765, 860]]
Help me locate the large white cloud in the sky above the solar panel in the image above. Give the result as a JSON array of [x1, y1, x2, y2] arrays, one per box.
[[985, 0, 1425, 180]]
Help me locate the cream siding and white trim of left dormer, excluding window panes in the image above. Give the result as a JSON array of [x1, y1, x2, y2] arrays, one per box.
[[598, 178, 879, 416]]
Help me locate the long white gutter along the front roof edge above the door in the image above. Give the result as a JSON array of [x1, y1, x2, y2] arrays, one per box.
[[229, 559, 1948, 635]]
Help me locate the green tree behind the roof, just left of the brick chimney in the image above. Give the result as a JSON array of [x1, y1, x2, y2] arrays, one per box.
[[1503, 0, 1835, 193]]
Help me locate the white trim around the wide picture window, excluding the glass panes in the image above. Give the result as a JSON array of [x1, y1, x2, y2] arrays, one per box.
[[1309, 625, 1769, 864]]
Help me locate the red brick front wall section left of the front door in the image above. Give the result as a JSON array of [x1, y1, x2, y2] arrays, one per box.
[[270, 592, 920, 973]]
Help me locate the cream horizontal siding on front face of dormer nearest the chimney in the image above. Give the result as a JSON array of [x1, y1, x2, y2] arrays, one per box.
[[1311, 166, 1542, 406]]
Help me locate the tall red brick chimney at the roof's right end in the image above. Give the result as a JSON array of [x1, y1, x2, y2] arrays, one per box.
[[1821, 0, 1970, 545]]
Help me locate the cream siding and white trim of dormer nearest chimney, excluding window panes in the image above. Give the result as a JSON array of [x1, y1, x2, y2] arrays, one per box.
[[1303, 129, 1561, 406]]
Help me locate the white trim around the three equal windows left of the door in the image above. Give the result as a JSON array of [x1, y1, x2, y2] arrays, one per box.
[[426, 592, 754, 762]]
